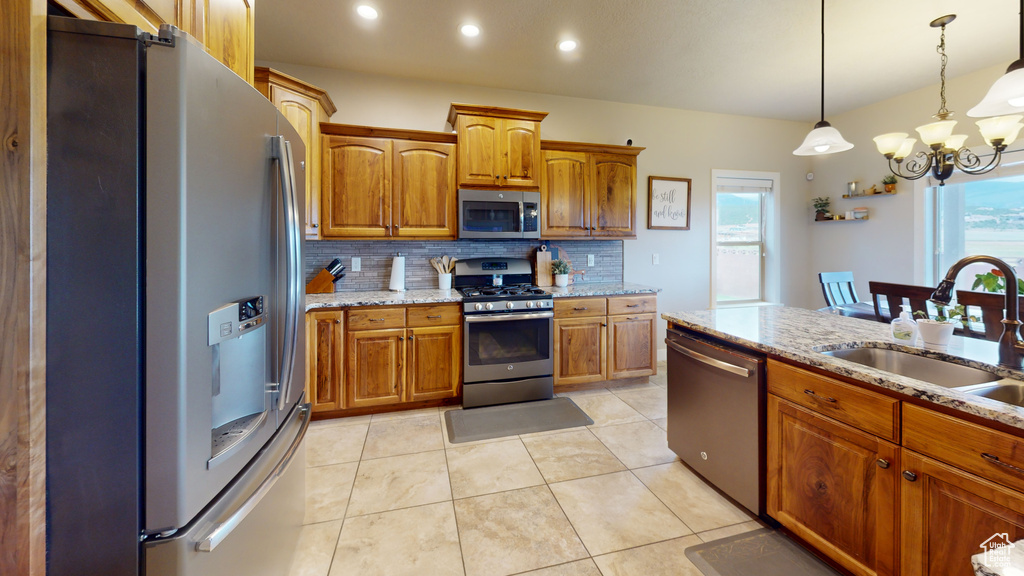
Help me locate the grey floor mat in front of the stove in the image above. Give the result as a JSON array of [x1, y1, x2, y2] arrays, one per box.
[[444, 398, 594, 444]]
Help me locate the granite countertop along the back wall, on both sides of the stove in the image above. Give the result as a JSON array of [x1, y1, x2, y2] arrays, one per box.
[[306, 282, 662, 312]]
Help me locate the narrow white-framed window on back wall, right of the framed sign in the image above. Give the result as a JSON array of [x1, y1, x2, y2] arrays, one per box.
[[712, 170, 778, 306]]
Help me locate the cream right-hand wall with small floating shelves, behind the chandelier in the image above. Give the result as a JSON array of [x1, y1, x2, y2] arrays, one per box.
[[807, 64, 1022, 300]]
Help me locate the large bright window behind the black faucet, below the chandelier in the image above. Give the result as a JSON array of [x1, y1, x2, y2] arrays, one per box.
[[926, 167, 1024, 290]]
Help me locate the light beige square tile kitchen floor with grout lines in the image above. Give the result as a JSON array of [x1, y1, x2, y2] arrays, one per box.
[[291, 364, 762, 576]]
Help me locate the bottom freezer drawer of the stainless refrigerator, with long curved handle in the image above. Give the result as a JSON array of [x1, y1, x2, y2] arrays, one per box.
[[142, 404, 309, 576]]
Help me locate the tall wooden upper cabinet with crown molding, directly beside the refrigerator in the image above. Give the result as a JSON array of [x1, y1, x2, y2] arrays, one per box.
[[255, 67, 337, 240]]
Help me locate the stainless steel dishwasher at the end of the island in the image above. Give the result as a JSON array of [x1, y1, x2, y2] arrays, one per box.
[[665, 327, 766, 517]]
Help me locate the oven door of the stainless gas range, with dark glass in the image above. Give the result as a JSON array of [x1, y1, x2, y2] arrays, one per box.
[[463, 312, 555, 383]]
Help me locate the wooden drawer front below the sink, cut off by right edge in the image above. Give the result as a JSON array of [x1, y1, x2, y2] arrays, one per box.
[[903, 404, 1024, 491]]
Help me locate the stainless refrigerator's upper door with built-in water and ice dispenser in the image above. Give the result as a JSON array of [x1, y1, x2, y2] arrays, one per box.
[[142, 25, 303, 534]]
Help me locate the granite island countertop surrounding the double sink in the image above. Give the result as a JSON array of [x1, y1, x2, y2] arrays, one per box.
[[662, 306, 1024, 429]]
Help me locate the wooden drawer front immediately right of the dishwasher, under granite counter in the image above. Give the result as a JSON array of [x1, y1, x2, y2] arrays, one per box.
[[768, 360, 900, 442]]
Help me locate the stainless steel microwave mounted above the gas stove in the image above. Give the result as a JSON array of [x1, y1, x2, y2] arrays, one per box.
[[459, 190, 541, 239]]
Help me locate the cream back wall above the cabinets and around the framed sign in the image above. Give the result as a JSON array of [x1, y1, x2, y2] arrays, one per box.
[[259, 63, 821, 342]]
